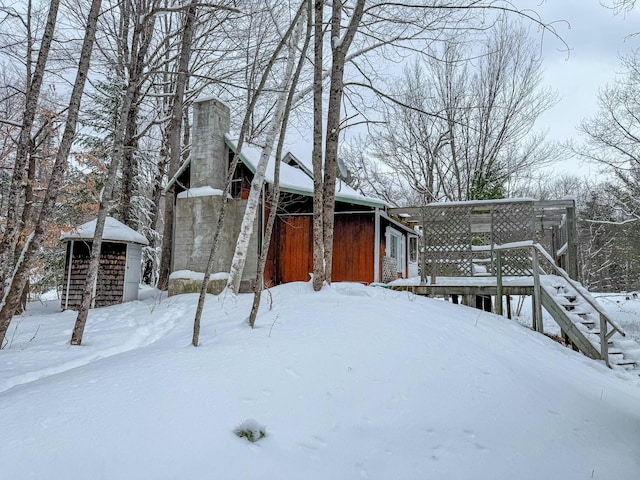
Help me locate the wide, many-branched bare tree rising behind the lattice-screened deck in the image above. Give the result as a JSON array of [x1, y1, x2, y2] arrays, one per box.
[[372, 19, 556, 202]]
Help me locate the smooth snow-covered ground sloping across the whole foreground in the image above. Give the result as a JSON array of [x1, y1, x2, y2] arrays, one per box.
[[0, 283, 640, 480]]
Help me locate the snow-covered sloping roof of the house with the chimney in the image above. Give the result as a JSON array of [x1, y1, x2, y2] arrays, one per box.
[[225, 135, 387, 207]]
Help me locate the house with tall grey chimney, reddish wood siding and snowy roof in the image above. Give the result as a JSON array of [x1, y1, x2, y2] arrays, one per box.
[[169, 99, 418, 292]]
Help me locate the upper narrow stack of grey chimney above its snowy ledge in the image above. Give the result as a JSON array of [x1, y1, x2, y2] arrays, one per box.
[[191, 98, 230, 190]]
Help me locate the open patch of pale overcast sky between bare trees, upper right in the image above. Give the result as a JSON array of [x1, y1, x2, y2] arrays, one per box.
[[518, 0, 640, 144]]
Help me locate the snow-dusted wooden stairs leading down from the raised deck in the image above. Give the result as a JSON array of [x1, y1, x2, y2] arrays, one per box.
[[540, 275, 640, 375]]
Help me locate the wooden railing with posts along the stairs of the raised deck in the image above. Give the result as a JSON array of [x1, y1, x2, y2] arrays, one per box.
[[493, 241, 626, 366]]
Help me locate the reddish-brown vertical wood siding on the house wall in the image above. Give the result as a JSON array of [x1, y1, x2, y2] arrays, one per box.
[[265, 213, 375, 285]]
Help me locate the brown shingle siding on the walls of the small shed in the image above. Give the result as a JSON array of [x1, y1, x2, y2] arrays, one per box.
[[62, 240, 127, 310]]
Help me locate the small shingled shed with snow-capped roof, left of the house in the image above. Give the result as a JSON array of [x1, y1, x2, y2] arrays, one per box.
[[61, 217, 149, 310]]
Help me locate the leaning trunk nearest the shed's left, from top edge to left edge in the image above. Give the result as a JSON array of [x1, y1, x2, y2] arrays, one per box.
[[0, 0, 102, 346]]
